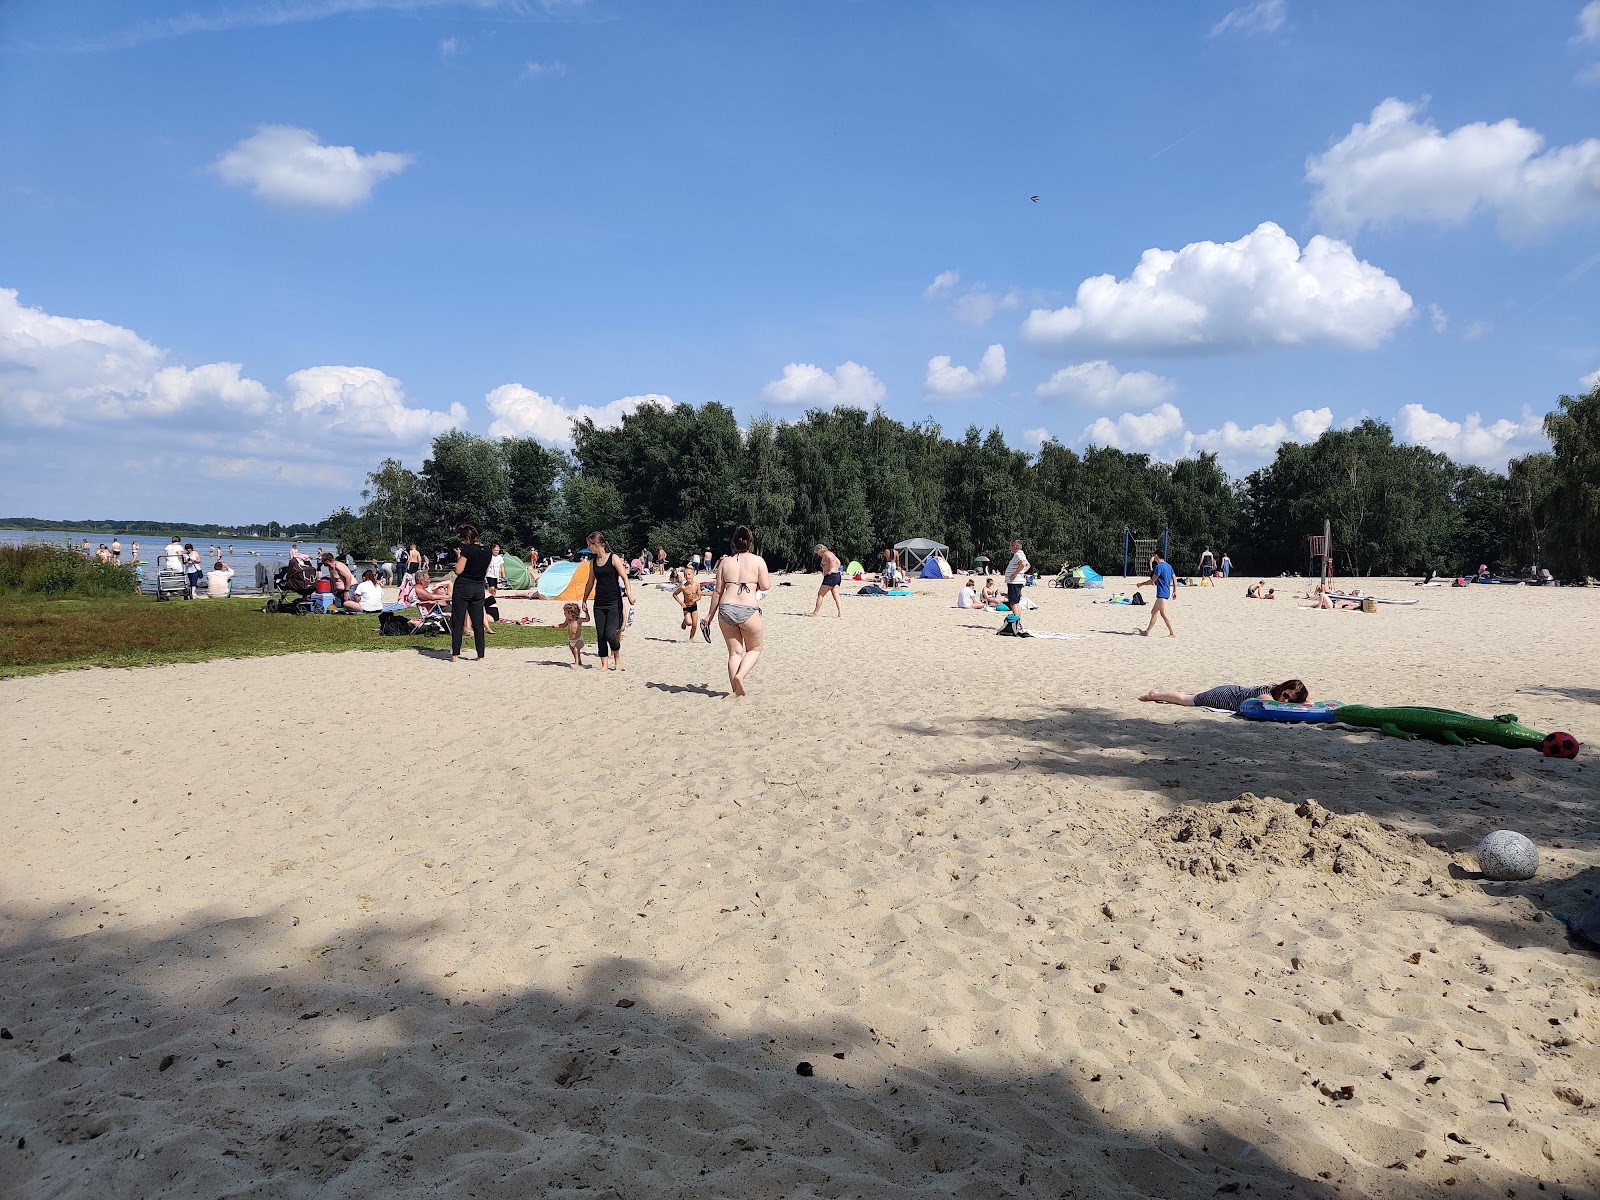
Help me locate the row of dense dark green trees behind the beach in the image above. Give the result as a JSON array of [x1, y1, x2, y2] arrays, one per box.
[[340, 387, 1600, 576]]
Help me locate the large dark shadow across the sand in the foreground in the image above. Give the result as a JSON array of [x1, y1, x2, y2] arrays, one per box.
[[0, 899, 1582, 1200]]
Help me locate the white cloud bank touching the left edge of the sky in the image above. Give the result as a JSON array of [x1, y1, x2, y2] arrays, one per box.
[[0, 288, 272, 426]]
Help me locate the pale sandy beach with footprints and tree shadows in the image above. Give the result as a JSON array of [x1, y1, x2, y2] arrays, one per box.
[[0, 576, 1600, 1200]]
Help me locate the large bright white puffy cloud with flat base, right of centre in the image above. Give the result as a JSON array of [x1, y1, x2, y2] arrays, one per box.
[[1022, 221, 1411, 352]]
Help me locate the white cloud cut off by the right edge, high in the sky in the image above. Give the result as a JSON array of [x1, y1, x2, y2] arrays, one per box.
[[1306, 98, 1600, 237]]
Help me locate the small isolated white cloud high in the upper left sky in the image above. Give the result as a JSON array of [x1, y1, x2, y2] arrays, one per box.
[[211, 125, 414, 210]]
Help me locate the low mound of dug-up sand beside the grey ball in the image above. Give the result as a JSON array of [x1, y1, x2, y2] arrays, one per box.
[[1147, 792, 1448, 882]]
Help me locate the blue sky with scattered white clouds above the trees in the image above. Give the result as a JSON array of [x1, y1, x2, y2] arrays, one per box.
[[0, 0, 1600, 522]]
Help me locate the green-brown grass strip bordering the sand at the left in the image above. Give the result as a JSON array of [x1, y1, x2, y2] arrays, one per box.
[[0, 595, 566, 678]]
